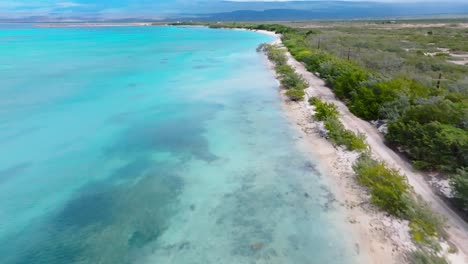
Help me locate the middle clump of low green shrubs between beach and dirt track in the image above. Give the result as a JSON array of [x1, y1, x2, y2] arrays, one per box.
[[309, 97, 367, 151]]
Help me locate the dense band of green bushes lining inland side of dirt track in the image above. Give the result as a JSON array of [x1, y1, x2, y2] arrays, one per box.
[[244, 22, 468, 210]]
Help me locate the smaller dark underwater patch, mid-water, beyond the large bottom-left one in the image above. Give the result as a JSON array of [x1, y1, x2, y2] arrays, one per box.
[[104, 104, 223, 162]]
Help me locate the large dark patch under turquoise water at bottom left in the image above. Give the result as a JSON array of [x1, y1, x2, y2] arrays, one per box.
[[6, 165, 184, 264]]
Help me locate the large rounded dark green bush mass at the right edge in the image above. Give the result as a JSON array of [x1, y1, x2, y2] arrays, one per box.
[[386, 95, 468, 172]]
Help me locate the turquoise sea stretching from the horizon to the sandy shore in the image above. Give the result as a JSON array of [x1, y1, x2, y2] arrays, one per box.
[[0, 25, 356, 264]]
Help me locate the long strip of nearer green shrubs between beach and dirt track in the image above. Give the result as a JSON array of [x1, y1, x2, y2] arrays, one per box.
[[309, 95, 446, 254]]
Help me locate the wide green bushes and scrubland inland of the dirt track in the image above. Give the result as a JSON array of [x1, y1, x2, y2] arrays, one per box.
[[283, 28, 468, 175]]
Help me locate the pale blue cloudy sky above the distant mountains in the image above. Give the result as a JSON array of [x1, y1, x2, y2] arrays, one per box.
[[0, 0, 468, 19]]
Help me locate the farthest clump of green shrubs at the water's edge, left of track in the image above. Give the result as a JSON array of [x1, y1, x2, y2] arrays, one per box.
[[257, 44, 309, 101]]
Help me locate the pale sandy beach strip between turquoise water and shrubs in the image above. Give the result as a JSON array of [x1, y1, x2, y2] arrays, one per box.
[[266, 31, 413, 264]]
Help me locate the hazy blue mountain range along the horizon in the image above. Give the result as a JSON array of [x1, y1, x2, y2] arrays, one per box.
[[0, 0, 468, 22]]
